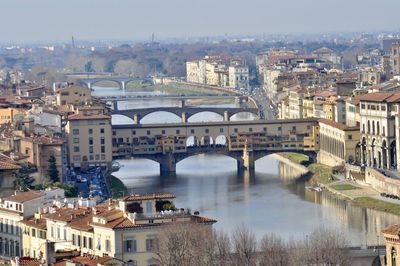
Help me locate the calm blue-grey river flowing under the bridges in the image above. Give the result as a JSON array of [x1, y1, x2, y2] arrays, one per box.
[[95, 88, 400, 246]]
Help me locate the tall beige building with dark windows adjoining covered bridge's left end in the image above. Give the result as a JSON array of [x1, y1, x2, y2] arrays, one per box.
[[65, 113, 112, 168]]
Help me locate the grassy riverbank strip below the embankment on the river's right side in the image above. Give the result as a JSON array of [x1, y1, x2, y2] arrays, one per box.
[[275, 153, 400, 215]]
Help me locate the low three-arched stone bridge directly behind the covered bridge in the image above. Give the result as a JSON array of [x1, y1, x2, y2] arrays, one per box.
[[112, 105, 259, 124]]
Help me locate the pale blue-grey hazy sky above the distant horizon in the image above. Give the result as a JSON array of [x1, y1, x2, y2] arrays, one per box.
[[0, 0, 400, 43]]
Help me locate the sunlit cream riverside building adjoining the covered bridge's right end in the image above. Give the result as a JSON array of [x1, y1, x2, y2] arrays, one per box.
[[317, 118, 361, 166]]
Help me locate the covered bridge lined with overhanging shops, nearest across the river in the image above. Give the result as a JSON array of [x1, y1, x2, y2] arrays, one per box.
[[112, 118, 319, 173]]
